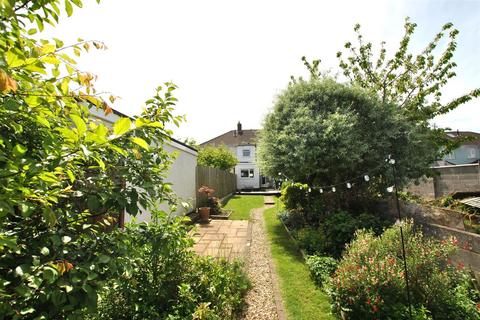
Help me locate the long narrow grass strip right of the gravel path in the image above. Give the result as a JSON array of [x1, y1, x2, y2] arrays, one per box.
[[264, 201, 335, 320]]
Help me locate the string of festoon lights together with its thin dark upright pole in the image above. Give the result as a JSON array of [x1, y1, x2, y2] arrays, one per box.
[[278, 155, 413, 319]]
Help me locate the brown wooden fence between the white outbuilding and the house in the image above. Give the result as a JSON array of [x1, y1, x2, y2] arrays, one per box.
[[196, 166, 237, 207]]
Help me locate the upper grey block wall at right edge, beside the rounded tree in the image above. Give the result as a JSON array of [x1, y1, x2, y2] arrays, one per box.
[[406, 163, 480, 199]]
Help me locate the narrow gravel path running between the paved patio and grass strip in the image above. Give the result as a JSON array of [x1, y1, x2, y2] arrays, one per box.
[[243, 205, 284, 320]]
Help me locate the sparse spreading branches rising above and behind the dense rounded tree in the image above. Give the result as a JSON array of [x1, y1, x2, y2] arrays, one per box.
[[304, 18, 480, 124]]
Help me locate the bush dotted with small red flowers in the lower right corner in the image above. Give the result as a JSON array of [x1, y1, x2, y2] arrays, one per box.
[[330, 221, 480, 320]]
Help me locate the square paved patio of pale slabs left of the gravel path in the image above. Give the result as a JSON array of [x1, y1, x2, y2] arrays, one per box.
[[192, 220, 251, 260]]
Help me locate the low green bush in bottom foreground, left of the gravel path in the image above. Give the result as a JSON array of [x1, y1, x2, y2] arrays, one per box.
[[91, 219, 249, 319]]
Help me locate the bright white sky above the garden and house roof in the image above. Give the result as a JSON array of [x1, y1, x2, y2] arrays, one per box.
[[40, 0, 480, 142]]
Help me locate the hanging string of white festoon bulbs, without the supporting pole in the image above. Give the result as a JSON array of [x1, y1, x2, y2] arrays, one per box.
[[278, 155, 395, 193]]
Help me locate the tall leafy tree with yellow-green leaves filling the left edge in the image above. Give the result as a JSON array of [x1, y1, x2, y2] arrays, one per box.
[[0, 0, 181, 319]]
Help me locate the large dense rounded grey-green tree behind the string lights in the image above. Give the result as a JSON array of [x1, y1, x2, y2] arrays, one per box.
[[257, 78, 439, 201]]
